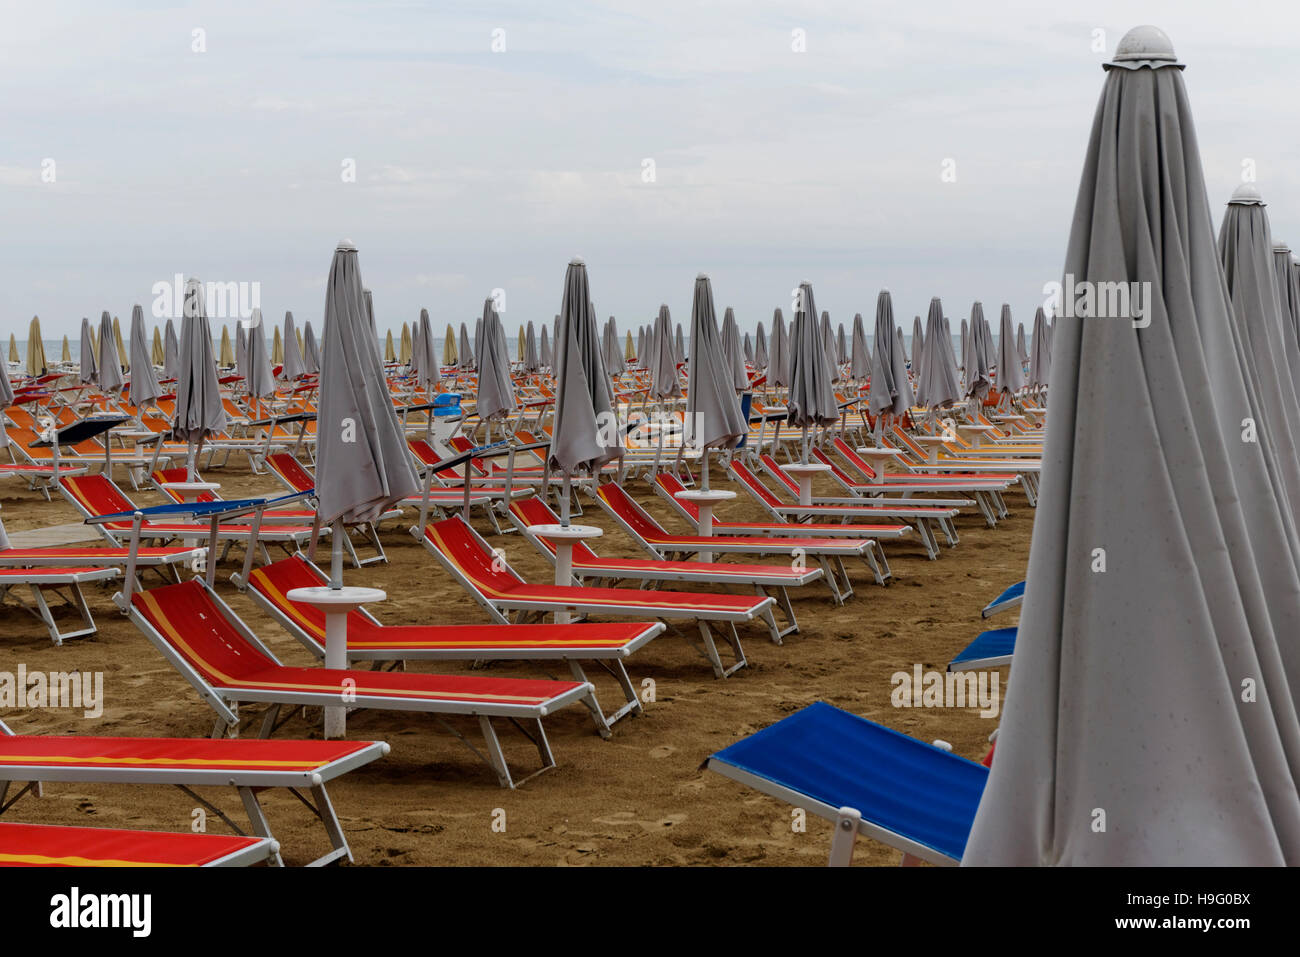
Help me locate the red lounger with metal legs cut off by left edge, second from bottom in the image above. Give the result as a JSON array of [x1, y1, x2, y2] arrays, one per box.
[[0, 724, 389, 866]]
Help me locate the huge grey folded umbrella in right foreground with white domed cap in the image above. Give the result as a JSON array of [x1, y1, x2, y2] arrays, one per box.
[[963, 27, 1300, 866]]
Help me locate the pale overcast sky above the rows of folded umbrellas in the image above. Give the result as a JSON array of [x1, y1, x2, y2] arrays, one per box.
[[0, 0, 1300, 338]]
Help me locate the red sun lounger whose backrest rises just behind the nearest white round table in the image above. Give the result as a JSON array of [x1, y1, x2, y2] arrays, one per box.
[[231, 554, 664, 724]]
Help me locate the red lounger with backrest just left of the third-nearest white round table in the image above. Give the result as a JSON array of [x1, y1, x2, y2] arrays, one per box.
[[595, 482, 889, 602]]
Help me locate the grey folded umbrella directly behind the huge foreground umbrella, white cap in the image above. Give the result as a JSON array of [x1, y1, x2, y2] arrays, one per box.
[[1218, 183, 1300, 518]]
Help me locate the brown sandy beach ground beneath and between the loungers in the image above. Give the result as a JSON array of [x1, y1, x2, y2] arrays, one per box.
[[0, 464, 1034, 866]]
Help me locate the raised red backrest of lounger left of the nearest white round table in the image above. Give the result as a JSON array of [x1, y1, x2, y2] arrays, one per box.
[[131, 579, 280, 685]]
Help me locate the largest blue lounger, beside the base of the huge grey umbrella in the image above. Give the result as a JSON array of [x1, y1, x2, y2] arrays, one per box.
[[709, 702, 988, 865]]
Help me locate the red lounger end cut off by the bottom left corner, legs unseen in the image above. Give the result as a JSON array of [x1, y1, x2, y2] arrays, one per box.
[[0, 823, 278, 867]]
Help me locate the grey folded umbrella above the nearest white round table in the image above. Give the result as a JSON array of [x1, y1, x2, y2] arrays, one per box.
[[316, 241, 420, 527]]
